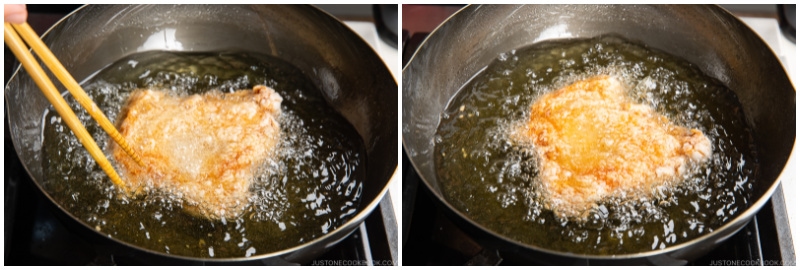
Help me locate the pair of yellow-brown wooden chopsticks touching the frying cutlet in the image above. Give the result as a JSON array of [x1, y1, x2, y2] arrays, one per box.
[[4, 23, 144, 191]]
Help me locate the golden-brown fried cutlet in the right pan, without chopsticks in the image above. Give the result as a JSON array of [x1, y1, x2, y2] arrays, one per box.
[[520, 76, 711, 217]]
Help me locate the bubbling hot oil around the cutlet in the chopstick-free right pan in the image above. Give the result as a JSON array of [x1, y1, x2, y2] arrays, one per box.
[[434, 36, 757, 255]]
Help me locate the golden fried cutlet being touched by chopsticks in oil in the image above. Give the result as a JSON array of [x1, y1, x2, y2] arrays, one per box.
[[112, 85, 282, 219]]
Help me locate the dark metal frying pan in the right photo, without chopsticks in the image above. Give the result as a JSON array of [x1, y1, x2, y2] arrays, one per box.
[[402, 5, 796, 264]]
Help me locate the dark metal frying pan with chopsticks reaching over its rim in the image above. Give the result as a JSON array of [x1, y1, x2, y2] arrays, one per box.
[[5, 5, 398, 264]]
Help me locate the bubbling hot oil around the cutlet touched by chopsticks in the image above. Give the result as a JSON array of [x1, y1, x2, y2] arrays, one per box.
[[43, 52, 365, 258]]
